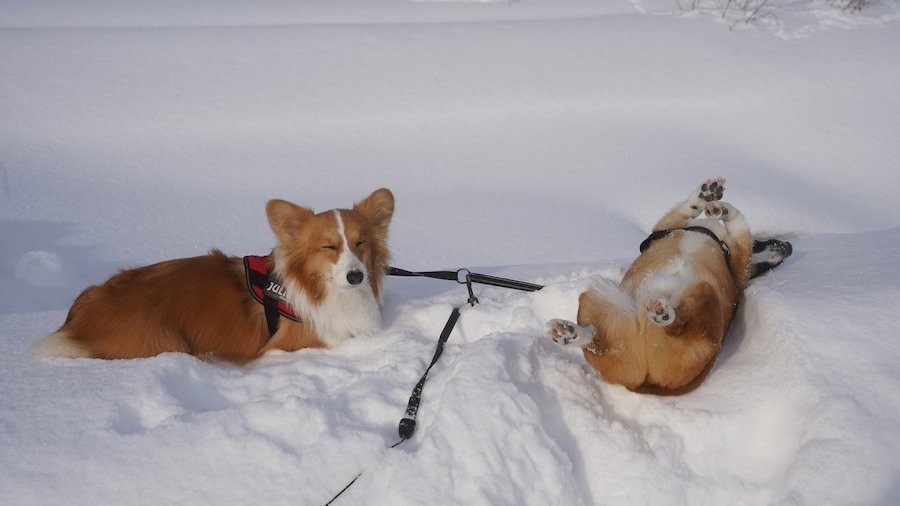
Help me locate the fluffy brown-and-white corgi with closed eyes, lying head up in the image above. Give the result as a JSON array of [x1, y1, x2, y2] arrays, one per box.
[[36, 188, 394, 363]]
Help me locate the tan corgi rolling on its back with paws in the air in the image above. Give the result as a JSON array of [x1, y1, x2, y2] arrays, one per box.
[[548, 179, 791, 395]]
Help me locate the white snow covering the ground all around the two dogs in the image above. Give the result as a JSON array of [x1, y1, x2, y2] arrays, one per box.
[[0, 0, 900, 505]]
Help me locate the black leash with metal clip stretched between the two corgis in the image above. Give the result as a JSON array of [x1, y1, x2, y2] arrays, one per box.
[[325, 267, 543, 506]]
